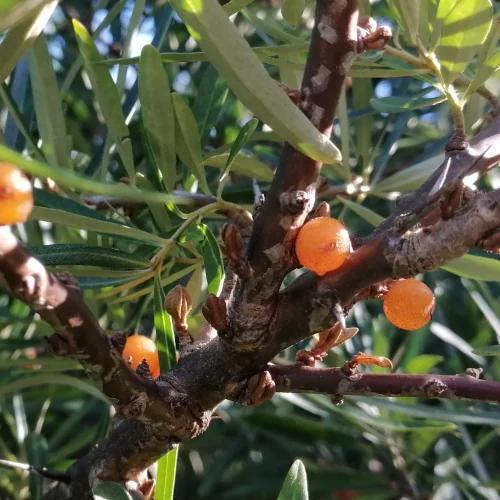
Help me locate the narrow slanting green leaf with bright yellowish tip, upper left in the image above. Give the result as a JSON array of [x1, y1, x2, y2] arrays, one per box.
[[73, 19, 135, 181]]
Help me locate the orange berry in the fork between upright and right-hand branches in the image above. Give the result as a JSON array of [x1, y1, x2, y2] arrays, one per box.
[[295, 217, 351, 275]]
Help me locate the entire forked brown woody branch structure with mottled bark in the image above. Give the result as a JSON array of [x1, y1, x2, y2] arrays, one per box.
[[0, 0, 500, 499]]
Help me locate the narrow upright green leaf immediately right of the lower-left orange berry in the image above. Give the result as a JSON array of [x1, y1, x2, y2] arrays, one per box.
[[154, 275, 177, 372]]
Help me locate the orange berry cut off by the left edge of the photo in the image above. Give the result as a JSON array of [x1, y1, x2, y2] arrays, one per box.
[[0, 162, 33, 225]]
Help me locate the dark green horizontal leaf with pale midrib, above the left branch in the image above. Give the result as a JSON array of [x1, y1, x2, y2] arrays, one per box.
[[29, 243, 150, 270]]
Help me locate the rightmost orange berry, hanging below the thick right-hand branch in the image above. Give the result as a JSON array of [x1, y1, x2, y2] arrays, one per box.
[[384, 279, 436, 330]]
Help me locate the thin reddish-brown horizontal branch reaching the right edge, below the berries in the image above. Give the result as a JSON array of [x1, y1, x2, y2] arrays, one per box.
[[267, 365, 500, 404]]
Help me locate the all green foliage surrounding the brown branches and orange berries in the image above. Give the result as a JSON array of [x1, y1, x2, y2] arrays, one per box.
[[0, 0, 500, 500]]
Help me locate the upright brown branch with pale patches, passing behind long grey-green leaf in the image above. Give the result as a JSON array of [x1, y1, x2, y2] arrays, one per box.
[[227, 0, 380, 351]]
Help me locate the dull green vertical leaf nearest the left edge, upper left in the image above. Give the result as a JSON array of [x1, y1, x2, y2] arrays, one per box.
[[30, 34, 71, 167]]
